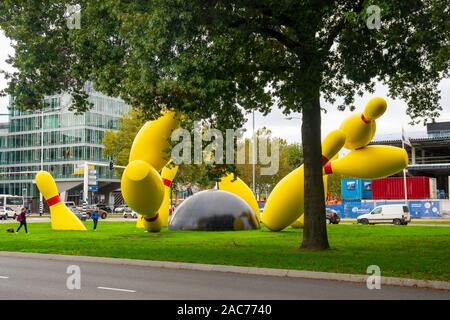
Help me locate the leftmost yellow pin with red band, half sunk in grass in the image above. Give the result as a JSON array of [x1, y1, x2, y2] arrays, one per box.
[[36, 171, 86, 231]]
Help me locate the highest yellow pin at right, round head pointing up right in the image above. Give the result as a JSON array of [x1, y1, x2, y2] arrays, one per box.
[[340, 97, 387, 150]]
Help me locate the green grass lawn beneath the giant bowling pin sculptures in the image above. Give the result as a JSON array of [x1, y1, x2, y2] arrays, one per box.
[[0, 221, 450, 281]]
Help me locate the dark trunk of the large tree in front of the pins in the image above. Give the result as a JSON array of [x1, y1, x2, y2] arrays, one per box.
[[301, 90, 329, 250]]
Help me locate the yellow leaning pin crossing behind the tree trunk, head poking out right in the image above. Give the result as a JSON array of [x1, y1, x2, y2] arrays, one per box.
[[262, 130, 345, 231]]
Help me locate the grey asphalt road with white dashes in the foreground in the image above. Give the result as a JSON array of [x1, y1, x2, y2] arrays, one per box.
[[0, 255, 450, 300]]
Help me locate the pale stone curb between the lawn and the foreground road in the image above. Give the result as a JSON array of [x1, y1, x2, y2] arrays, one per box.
[[0, 251, 450, 290]]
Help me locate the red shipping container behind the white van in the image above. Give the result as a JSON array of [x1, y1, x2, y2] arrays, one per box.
[[372, 177, 430, 200]]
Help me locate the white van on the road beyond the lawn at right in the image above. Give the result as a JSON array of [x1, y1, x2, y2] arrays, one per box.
[[357, 204, 411, 225]]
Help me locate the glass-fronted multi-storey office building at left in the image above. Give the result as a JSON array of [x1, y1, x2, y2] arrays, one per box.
[[0, 91, 129, 198]]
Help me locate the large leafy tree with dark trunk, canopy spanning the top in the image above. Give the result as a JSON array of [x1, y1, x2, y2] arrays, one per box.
[[0, 0, 450, 249]]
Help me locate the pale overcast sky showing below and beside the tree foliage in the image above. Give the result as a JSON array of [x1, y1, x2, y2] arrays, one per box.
[[0, 30, 450, 142]]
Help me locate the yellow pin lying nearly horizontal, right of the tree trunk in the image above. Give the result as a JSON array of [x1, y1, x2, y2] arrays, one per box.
[[324, 146, 408, 179]]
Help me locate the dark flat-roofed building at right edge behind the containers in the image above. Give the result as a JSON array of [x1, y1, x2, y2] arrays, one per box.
[[371, 122, 450, 199]]
